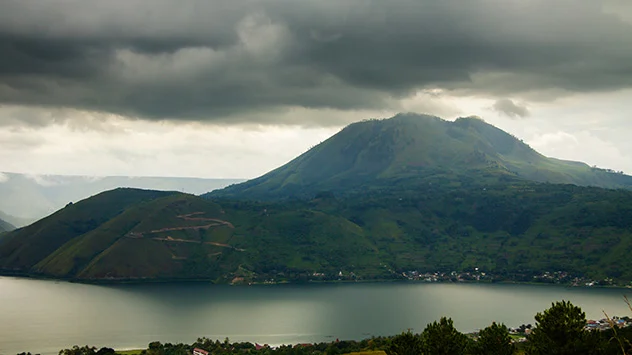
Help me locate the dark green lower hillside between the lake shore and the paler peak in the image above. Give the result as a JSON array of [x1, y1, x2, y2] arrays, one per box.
[[0, 185, 632, 283]]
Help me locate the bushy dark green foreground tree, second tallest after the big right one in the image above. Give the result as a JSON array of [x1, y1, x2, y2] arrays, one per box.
[[421, 317, 468, 355]]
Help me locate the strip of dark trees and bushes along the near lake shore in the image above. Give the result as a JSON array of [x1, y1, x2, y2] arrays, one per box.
[[20, 301, 632, 355]]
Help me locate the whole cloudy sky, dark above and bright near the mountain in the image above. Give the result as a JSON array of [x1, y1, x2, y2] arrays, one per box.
[[0, 0, 632, 178]]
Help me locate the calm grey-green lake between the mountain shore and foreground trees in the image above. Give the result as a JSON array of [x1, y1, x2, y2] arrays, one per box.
[[0, 277, 632, 355]]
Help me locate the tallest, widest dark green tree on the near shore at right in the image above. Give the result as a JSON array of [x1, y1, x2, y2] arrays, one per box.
[[526, 301, 596, 355]]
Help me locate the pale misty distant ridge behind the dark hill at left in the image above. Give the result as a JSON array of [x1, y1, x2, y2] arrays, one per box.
[[0, 173, 243, 227]]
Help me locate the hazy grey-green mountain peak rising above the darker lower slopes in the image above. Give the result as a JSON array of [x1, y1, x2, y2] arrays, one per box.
[[208, 114, 632, 200]]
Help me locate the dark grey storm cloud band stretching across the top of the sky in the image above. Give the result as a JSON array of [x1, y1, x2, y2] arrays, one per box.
[[0, 0, 632, 124]]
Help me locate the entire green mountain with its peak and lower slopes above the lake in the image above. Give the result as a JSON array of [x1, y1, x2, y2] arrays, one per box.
[[0, 115, 632, 284]]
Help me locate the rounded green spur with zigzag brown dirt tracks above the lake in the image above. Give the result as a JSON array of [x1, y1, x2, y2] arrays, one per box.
[[32, 193, 244, 279]]
